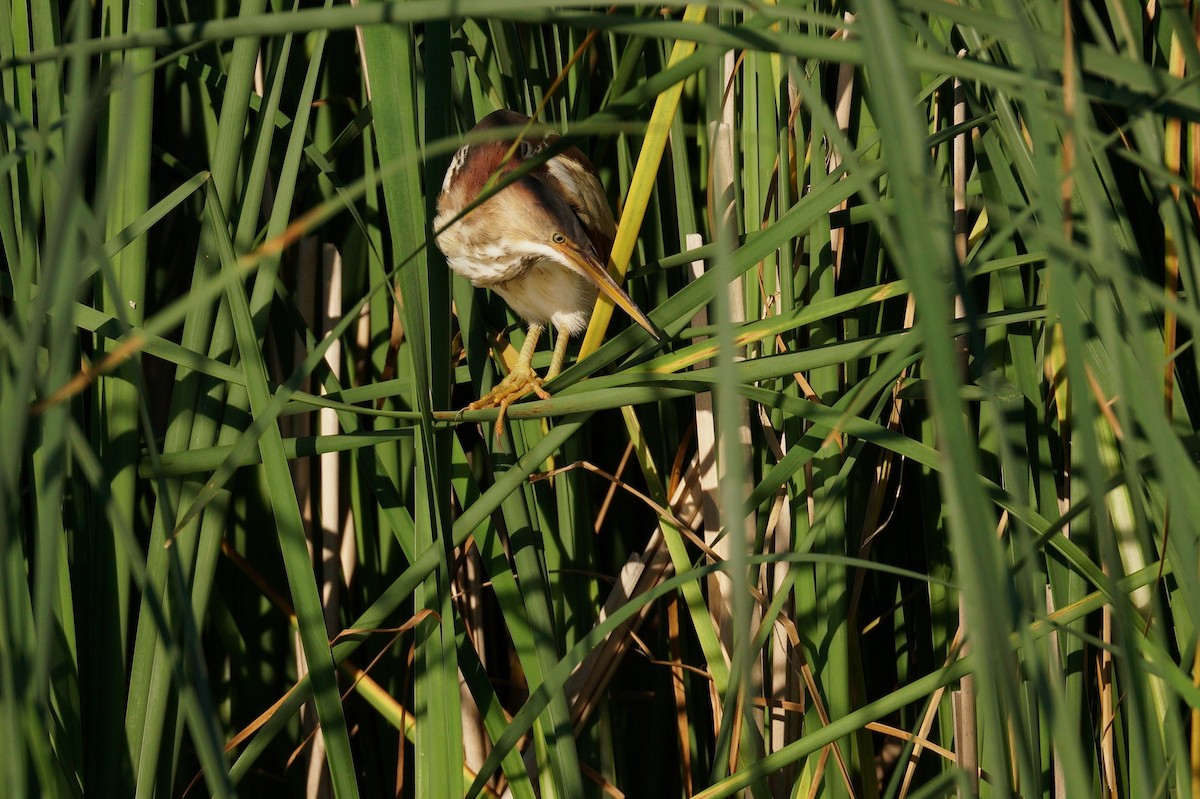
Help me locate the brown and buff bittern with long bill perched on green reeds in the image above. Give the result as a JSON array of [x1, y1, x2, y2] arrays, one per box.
[[433, 109, 661, 438]]
